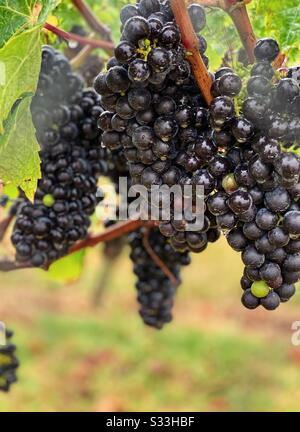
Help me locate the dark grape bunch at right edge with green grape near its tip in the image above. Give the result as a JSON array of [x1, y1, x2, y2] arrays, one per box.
[[208, 38, 300, 310]]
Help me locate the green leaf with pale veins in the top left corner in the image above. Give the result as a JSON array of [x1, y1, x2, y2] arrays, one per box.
[[0, 0, 59, 47]]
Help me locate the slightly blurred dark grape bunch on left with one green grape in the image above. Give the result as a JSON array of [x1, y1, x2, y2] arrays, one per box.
[[12, 46, 107, 267]]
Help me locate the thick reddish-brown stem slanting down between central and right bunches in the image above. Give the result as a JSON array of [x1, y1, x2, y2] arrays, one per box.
[[171, 0, 213, 105]]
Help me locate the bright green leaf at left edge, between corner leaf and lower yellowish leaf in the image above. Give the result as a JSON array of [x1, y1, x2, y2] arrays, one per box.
[[0, 27, 41, 134]]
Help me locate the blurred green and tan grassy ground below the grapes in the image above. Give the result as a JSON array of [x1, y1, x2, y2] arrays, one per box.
[[0, 241, 300, 412]]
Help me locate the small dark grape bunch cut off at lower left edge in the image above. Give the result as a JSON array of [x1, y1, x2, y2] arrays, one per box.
[[0, 330, 19, 392]]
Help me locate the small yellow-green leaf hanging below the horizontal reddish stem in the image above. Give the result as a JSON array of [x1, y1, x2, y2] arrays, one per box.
[[47, 250, 85, 283]]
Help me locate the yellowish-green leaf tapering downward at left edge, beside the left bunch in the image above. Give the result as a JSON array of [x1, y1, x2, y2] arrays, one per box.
[[0, 97, 41, 200]]
